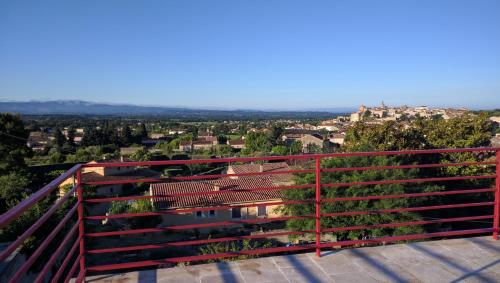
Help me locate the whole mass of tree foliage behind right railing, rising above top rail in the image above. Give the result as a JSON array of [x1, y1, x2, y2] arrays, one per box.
[[284, 115, 492, 240]]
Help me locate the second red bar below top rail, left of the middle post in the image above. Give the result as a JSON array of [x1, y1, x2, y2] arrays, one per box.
[[85, 184, 314, 203]]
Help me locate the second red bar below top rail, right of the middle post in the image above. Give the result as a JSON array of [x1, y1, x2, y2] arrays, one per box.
[[321, 175, 496, 188]]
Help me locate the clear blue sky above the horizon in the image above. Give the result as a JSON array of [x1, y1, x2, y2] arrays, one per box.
[[0, 0, 500, 110]]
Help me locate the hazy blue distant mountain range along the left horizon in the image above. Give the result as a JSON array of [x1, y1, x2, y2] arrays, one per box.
[[0, 100, 353, 118]]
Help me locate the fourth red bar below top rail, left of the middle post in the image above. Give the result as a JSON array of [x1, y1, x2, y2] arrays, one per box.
[[85, 215, 315, 237]]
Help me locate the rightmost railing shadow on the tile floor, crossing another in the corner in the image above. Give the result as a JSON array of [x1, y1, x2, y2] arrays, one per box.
[[408, 243, 498, 282]]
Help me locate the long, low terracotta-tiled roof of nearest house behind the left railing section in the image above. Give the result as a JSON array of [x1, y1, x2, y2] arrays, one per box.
[[150, 177, 284, 209]]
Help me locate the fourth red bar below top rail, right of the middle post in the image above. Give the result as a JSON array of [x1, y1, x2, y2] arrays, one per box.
[[321, 201, 495, 217]]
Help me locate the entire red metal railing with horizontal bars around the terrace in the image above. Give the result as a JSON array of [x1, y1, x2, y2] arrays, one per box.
[[0, 148, 500, 282]]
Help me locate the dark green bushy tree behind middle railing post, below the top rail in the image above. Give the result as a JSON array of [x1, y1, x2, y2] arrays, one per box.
[[284, 156, 443, 243]]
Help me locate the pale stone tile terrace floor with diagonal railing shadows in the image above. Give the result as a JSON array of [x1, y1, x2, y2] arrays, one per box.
[[87, 236, 500, 283]]
